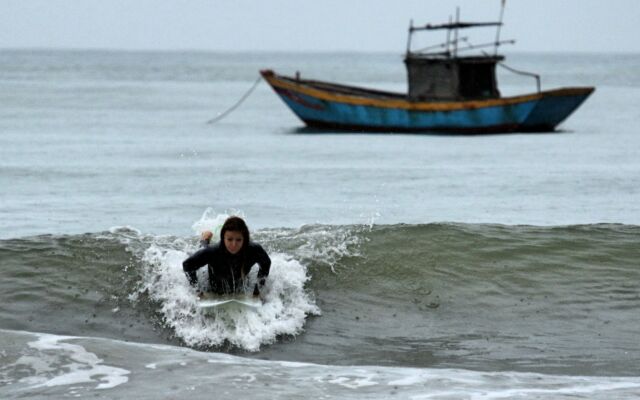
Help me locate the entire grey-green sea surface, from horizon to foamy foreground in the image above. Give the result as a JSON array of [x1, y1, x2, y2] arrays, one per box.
[[0, 50, 640, 399]]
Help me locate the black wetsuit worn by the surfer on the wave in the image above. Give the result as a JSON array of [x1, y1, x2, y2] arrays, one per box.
[[182, 241, 271, 294]]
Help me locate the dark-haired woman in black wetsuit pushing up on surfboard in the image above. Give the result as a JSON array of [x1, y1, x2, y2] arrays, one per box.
[[182, 216, 271, 296]]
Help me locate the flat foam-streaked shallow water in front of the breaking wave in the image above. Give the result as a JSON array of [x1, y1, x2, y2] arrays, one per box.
[[0, 330, 640, 399]]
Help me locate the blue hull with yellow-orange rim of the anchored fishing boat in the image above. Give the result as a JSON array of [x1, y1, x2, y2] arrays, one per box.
[[262, 71, 594, 133]]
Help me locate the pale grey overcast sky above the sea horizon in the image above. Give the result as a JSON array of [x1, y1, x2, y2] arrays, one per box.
[[0, 0, 640, 53]]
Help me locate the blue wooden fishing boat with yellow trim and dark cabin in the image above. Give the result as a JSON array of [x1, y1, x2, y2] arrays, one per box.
[[260, 3, 594, 133]]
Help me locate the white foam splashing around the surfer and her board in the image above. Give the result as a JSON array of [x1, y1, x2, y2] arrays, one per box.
[[131, 211, 320, 351]]
